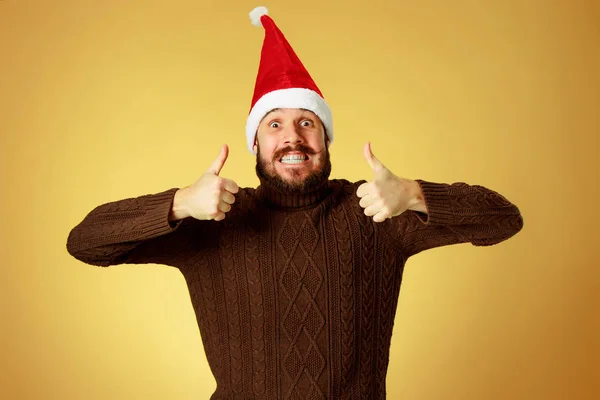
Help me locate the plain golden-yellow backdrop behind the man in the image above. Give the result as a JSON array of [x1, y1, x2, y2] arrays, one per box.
[[0, 0, 600, 400]]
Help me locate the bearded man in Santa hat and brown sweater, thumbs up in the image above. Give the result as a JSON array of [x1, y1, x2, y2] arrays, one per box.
[[67, 8, 523, 399]]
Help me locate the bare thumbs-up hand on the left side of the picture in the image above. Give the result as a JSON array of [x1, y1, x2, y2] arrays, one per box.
[[169, 144, 240, 221]]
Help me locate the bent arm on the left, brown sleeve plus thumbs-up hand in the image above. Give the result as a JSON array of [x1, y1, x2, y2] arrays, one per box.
[[67, 145, 239, 266]]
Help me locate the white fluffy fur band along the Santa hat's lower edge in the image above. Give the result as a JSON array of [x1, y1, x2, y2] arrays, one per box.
[[246, 88, 333, 154]]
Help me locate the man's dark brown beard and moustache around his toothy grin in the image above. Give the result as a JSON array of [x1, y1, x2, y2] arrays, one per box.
[[256, 143, 331, 194]]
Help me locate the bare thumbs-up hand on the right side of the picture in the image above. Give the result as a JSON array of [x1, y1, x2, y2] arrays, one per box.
[[356, 142, 422, 222]]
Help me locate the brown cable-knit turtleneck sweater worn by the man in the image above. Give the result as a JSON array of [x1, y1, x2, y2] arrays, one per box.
[[67, 179, 523, 400]]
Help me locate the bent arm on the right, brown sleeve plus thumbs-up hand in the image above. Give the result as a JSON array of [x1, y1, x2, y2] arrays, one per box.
[[356, 142, 523, 257]]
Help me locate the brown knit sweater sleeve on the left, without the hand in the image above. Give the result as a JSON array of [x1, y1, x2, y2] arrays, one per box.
[[67, 188, 189, 267]]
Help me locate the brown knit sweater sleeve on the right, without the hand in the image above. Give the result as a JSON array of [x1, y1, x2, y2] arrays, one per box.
[[390, 179, 523, 257]]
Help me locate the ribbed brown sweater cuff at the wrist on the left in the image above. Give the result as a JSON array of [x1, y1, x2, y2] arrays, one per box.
[[138, 188, 183, 238]]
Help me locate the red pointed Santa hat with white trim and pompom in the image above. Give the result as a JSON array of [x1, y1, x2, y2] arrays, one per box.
[[246, 7, 333, 154]]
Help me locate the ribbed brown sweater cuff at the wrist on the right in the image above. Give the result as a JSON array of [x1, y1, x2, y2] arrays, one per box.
[[415, 179, 455, 225]]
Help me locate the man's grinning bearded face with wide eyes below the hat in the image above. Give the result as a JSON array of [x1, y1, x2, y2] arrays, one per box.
[[254, 108, 331, 193]]
